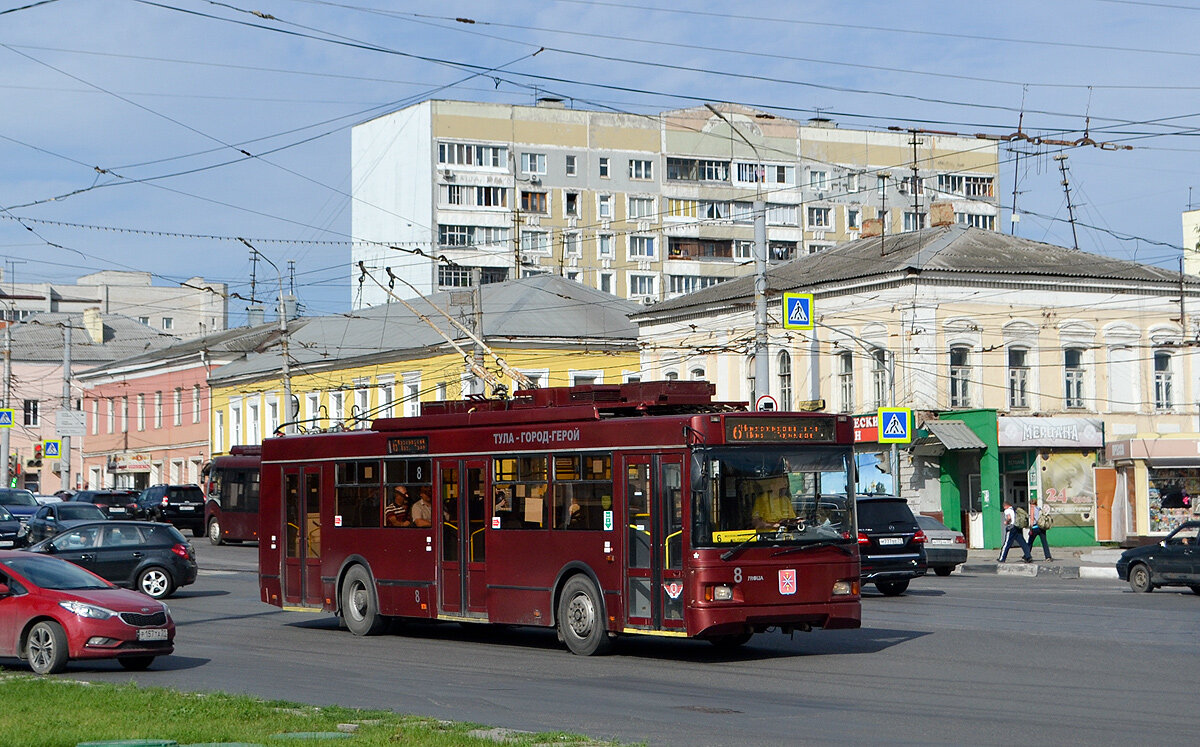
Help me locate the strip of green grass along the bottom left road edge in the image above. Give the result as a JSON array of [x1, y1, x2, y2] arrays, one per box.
[[0, 669, 619, 747]]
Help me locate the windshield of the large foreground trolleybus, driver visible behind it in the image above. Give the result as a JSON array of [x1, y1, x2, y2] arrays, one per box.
[[692, 446, 854, 546]]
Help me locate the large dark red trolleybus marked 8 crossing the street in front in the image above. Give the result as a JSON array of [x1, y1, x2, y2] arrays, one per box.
[[259, 382, 860, 655]]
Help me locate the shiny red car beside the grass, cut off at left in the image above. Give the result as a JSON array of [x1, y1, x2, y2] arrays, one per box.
[[0, 550, 175, 675]]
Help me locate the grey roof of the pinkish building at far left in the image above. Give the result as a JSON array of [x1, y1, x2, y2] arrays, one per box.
[[12, 311, 179, 367]]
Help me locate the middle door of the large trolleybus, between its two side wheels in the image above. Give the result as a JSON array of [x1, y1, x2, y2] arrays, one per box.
[[437, 460, 488, 618]]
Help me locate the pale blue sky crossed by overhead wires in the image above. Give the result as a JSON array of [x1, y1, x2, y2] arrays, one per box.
[[0, 0, 1200, 319]]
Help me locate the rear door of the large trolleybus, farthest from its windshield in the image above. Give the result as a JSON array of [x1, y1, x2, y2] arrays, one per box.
[[283, 466, 322, 606]]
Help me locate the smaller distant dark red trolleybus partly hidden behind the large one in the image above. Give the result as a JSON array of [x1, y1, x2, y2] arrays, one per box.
[[204, 446, 263, 545]]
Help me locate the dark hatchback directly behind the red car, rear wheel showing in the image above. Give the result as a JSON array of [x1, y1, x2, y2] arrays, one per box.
[[28, 519, 196, 599]]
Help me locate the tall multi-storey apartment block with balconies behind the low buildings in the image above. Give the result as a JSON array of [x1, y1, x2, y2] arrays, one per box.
[[352, 100, 998, 307]]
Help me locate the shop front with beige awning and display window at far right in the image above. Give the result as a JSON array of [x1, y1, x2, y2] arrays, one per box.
[[1106, 434, 1200, 544]]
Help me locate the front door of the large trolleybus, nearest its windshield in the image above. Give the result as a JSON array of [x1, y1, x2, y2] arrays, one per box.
[[624, 454, 684, 632]]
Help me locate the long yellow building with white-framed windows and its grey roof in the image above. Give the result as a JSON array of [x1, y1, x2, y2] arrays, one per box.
[[209, 275, 640, 456]]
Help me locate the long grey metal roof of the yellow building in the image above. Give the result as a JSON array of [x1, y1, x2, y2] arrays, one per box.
[[211, 275, 641, 382]]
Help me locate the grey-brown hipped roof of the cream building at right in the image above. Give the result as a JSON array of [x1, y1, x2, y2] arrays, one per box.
[[635, 225, 1200, 319]]
